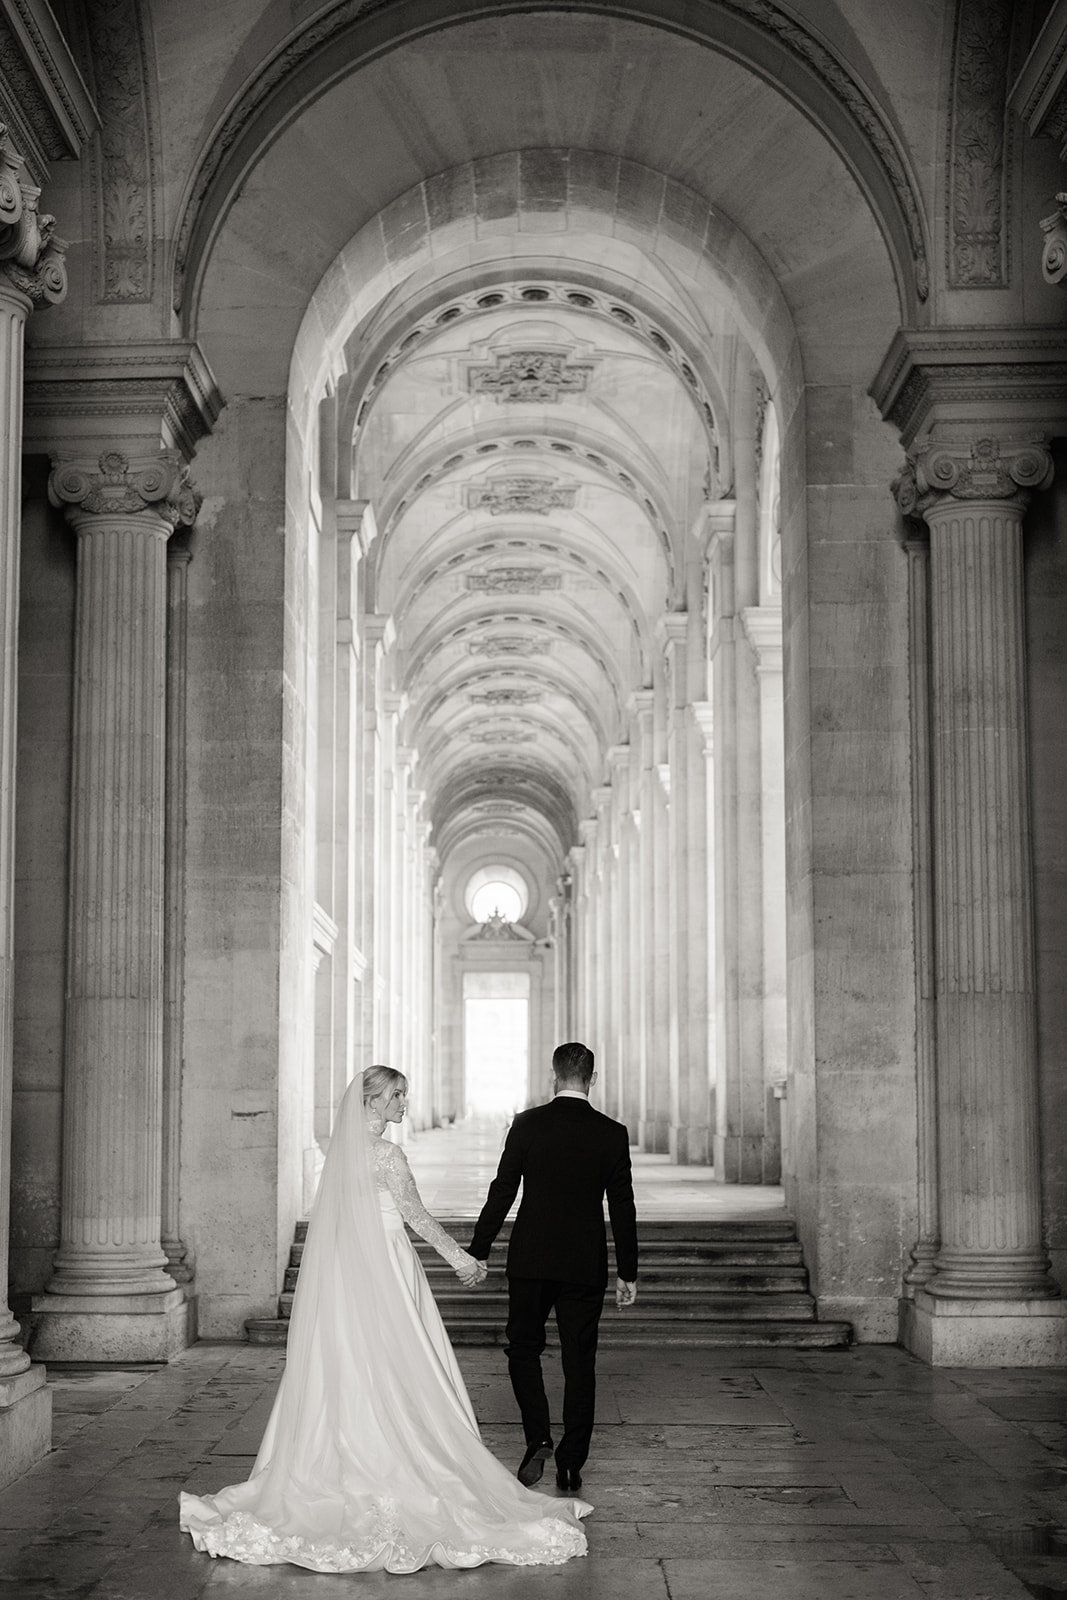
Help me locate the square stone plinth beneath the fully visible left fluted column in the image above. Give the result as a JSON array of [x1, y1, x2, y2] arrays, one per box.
[[30, 1288, 197, 1362]]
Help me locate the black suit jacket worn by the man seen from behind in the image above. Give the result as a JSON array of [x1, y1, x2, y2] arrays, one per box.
[[470, 1094, 637, 1288]]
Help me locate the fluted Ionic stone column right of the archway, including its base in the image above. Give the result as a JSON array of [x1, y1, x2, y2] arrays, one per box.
[[897, 438, 1067, 1365]]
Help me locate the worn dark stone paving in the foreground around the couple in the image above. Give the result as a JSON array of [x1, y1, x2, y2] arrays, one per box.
[[0, 1344, 1067, 1600]]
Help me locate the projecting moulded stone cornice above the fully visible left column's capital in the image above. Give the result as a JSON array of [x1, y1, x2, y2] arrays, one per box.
[[24, 339, 222, 459]]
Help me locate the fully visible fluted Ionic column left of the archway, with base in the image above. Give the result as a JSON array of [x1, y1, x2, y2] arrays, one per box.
[[34, 450, 197, 1362]]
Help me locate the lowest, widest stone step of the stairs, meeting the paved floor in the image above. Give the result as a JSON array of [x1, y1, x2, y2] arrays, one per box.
[[245, 1314, 853, 1350]]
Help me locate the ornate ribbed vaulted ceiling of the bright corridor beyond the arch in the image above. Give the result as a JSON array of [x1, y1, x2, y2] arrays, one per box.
[[346, 259, 725, 889]]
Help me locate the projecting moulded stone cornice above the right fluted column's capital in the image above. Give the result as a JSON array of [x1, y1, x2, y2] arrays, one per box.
[[869, 326, 1067, 450]]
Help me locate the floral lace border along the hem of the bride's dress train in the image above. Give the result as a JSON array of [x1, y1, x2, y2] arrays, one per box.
[[181, 1498, 587, 1573]]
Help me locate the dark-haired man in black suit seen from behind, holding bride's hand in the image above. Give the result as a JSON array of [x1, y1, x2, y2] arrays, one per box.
[[470, 1043, 637, 1490]]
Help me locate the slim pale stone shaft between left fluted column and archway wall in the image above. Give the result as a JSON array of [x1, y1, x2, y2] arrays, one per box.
[[160, 538, 192, 1283]]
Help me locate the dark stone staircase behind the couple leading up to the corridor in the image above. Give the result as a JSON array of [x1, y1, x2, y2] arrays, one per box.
[[245, 1218, 851, 1350]]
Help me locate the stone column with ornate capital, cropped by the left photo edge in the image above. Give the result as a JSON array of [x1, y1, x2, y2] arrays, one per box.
[[0, 140, 67, 1486]]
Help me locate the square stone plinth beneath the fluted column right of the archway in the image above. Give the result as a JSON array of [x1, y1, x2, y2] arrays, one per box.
[[899, 1286, 1067, 1366]]
